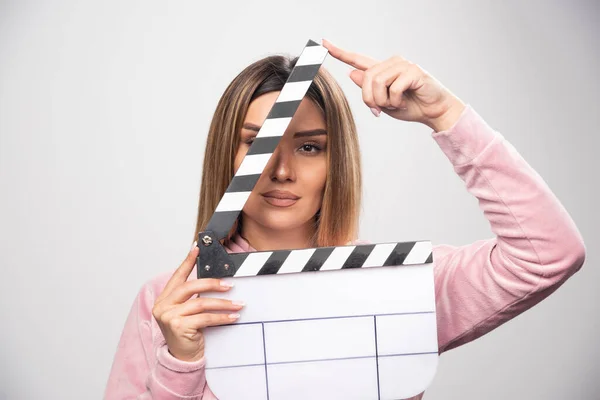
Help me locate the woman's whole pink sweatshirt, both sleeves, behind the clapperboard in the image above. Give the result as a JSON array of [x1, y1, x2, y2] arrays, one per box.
[[105, 106, 585, 400]]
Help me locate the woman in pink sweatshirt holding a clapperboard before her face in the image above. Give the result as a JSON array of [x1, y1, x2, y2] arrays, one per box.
[[106, 41, 585, 400]]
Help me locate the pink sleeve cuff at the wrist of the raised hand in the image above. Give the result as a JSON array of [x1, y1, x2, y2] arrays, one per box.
[[431, 105, 502, 166]]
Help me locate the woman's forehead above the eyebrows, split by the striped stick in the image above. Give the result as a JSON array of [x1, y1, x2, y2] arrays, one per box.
[[244, 92, 325, 129]]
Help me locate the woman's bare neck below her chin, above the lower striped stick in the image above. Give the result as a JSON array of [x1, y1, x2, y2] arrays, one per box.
[[241, 218, 315, 251]]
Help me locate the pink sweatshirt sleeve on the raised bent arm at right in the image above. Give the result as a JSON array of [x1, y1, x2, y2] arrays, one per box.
[[431, 105, 585, 353]]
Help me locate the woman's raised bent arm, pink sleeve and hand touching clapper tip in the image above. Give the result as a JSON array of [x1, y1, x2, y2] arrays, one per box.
[[323, 41, 585, 351]]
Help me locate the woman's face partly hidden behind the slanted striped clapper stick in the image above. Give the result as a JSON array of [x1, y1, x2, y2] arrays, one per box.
[[234, 92, 327, 234]]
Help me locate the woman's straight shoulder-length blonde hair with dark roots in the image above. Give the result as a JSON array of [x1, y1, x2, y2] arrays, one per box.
[[194, 55, 362, 247]]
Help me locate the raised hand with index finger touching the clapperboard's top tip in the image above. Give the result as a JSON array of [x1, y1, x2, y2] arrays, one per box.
[[323, 40, 465, 132]]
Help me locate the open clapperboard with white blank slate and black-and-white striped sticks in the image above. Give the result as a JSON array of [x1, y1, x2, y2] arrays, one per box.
[[197, 40, 438, 400]]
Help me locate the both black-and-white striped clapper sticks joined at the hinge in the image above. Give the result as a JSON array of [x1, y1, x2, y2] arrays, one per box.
[[197, 40, 433, 278]]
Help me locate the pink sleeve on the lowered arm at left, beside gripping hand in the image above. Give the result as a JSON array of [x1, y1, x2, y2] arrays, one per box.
[[104, 284, 215, 400]]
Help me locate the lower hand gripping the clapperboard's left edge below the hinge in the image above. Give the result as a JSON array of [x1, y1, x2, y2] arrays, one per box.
[[152, 242, 244, 361]]
